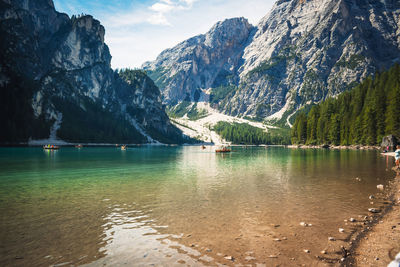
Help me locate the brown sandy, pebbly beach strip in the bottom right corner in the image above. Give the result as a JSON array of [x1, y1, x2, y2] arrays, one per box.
[[341, 167, 400, 266]]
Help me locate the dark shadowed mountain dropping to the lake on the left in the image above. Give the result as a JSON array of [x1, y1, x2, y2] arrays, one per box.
[[0, 0, 184, 143]]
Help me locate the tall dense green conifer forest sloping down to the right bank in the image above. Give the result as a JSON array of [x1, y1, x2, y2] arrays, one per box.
[[291, 64, 400, 145]]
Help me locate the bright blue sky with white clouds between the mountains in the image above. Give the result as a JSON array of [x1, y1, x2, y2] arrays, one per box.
[[54, 0, 275, 69]]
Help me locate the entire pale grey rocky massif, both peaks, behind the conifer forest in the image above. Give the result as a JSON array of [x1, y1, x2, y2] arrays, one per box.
[[143, 0, 400, 125]]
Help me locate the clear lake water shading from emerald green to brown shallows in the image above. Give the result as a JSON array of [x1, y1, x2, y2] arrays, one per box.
[[0, 146, 394, 266]]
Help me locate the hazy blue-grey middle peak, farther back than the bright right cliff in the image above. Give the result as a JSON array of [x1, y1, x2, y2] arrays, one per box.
[[143, 18, 253, 104]]
